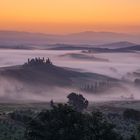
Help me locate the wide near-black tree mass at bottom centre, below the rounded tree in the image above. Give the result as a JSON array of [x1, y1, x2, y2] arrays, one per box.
[[25, 104, 120, 140]]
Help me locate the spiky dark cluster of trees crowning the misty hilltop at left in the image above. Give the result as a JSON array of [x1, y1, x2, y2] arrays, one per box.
[[24, 57, 52, 66]]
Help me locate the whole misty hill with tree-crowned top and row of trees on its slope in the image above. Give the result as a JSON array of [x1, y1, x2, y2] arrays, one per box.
[[0, 58, 118, 99]]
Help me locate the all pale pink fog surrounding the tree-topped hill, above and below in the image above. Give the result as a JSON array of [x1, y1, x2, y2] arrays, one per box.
[[0, 50, 140, 101]]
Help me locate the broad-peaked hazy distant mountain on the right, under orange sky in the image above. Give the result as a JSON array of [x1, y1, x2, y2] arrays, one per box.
[[67, 31, 140, 45]]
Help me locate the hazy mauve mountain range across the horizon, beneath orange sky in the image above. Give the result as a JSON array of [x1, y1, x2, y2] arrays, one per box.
[[0, 31, 140, 47]]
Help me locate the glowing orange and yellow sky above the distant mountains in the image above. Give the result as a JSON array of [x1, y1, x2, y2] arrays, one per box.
[[0, 0, 140, 34]]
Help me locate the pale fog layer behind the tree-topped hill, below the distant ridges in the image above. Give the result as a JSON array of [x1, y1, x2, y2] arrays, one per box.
[[0, 50, 140, 78]]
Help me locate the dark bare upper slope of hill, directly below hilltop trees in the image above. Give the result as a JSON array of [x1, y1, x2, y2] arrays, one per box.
[[0, 58, 114, 86]]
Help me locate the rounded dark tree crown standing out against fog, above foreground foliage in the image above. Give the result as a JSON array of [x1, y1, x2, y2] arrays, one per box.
[[67, 92, 88, 111]]
